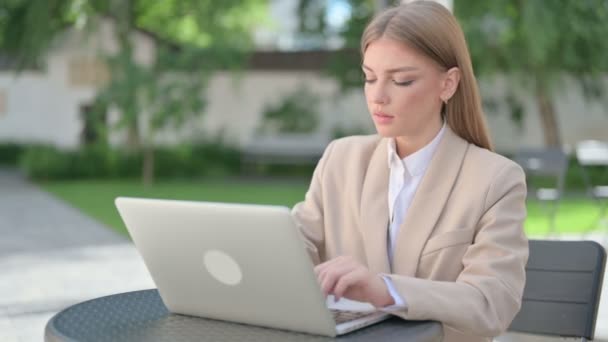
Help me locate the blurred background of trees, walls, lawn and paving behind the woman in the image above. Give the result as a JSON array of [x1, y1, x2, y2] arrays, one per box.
[[0, 0, 608, 341]]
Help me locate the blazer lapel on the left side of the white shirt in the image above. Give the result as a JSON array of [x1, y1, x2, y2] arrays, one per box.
[[359, 139, 390, 273]]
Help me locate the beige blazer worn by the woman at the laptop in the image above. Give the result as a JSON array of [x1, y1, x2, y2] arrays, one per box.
[[293, 128, 528, 342]]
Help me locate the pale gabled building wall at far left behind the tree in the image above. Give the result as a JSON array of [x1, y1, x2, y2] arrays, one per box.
[[0, 20, 154, 148]]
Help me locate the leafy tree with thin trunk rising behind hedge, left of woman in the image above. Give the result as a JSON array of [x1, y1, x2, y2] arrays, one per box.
[[98, 0, 262, 184]]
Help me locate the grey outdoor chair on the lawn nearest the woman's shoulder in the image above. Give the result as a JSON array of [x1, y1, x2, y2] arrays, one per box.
[[514, 148, 568, 234]]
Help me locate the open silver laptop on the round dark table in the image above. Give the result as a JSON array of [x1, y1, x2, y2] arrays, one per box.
[[115, 197, 389, 337]]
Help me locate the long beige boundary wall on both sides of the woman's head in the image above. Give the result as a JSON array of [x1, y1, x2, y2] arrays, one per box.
[[183, 71, 608, 152]]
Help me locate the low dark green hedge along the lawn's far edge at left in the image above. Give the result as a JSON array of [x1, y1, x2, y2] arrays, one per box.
[[19, 142, 241, 180]]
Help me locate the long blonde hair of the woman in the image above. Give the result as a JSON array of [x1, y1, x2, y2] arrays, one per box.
[[361, 1, 492, 150]]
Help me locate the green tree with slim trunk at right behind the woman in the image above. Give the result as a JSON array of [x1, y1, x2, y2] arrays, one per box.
[[454, 0, 608, 146]]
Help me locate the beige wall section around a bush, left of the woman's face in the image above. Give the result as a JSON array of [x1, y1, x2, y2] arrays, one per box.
[[188, 71, 373, 144]]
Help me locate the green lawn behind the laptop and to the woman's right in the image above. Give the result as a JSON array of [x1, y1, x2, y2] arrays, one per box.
[[40, 180, 598, 236]]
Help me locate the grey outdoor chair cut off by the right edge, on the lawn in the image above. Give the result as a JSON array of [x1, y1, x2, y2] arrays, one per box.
[[576, 140, 608, 234]]
